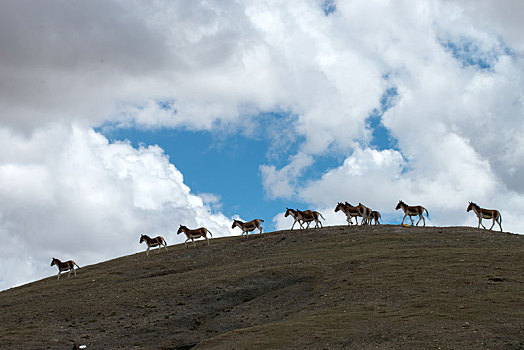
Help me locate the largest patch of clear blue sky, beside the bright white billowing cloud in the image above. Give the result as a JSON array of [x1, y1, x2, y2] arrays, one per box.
[[98, 123, 305, 230]]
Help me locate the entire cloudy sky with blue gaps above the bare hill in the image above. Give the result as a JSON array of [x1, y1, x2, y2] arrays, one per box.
[[0, 0, 524, 290]]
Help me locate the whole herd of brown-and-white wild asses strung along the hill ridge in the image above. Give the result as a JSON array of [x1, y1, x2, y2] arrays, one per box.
[[51, 201, 502, 279]]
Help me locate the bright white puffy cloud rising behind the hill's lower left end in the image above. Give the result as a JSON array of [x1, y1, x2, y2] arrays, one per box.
[[0, 125, 232, 288]]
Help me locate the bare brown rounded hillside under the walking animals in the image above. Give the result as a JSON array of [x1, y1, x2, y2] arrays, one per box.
[[0, 225, 524, 349]]
